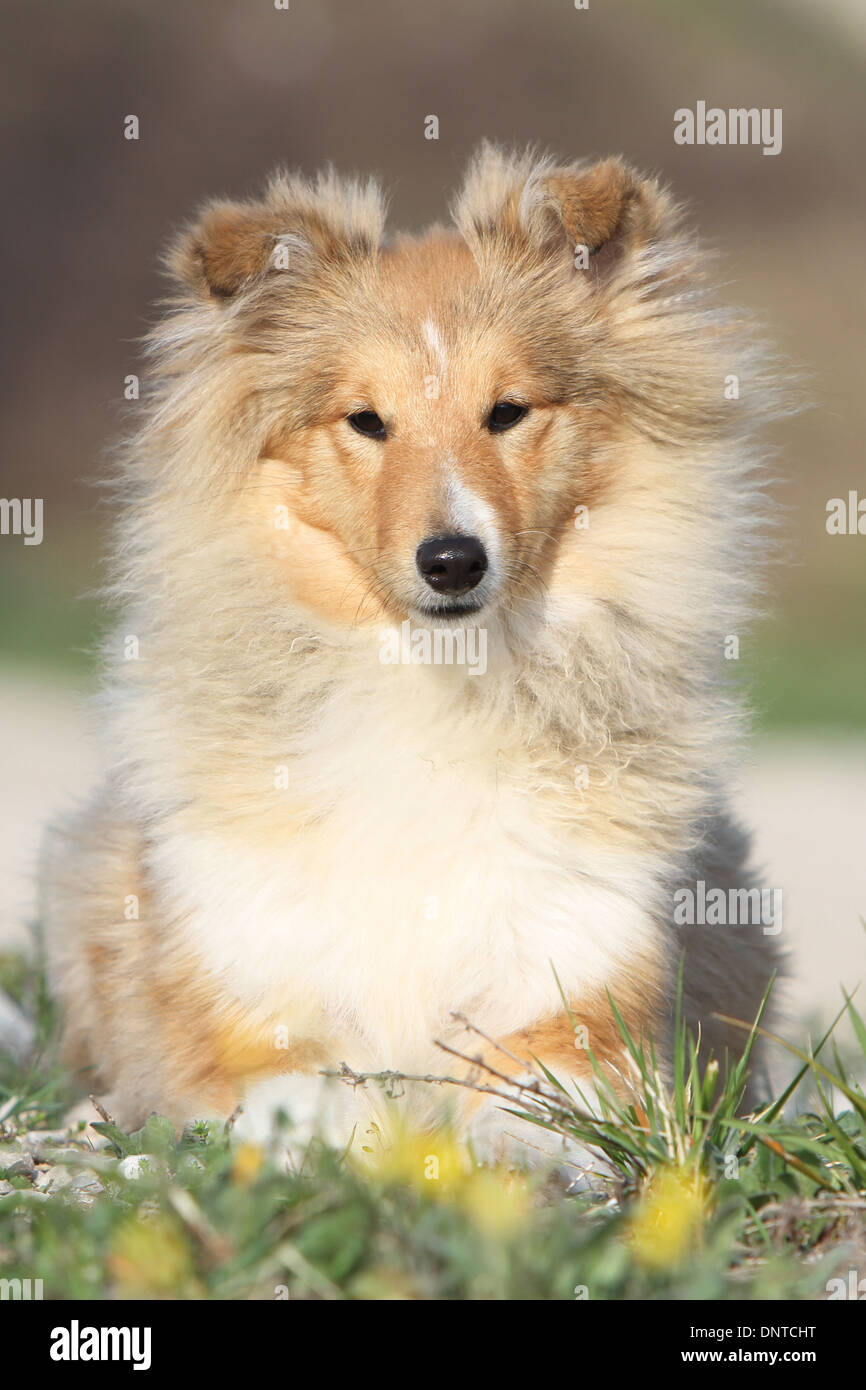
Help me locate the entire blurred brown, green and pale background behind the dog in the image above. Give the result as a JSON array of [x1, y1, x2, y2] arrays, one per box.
[[0, 0, 866, 1045]]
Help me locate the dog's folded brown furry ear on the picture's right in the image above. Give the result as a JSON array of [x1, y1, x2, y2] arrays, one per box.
[[455, 145, 676, 277]]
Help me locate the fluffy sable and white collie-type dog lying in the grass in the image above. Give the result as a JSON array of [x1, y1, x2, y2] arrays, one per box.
[[44, 146, 776, 1154]]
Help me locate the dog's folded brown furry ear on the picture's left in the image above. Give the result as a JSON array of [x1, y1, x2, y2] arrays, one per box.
[[165, 171, 385, 300]]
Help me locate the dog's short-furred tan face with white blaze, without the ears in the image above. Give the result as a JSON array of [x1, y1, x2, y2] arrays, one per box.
[[257, 236, 606, 621]]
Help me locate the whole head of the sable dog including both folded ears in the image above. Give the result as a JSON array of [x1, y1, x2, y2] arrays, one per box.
[[166, 150, 686, 623]]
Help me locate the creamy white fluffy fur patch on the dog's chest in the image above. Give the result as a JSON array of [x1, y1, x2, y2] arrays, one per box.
[[149, 656, 661, 1069]]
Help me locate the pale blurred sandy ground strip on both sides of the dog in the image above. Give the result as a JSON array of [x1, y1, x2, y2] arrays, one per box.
[[0, 674, 866, 1019]]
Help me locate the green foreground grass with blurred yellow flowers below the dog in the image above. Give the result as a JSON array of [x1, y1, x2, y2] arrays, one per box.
[[0, 958, 866, 1300]]
